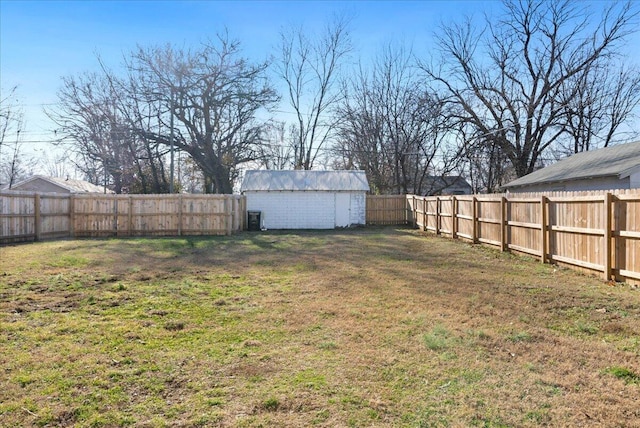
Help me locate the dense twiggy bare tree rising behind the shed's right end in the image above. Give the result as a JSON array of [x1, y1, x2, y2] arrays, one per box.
[[335, 47, 456, 194]]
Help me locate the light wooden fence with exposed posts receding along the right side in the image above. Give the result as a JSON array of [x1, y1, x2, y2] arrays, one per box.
[[404, 190, 640, 281]]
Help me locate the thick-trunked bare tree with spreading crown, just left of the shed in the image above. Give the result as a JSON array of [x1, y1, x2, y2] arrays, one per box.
[[127, 37, 278, 193]]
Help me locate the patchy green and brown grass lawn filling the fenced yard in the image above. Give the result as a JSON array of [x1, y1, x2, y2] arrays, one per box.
[[0, 228, 640, 427]]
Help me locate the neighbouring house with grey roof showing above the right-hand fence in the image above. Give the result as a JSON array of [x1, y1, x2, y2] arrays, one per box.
[[503, 142, 640, 192]]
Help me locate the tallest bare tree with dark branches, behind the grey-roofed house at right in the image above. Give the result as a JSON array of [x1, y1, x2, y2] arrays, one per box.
[[422, 0, 636, 181]]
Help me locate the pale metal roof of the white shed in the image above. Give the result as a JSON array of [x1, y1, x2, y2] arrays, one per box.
[[240, 170, 369, 192]]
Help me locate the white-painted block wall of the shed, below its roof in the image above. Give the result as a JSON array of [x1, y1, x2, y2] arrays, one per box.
[[245, 191, 366, 229]]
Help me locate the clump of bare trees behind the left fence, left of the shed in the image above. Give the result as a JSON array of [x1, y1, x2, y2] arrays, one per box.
[[49, 37, 278, 193]]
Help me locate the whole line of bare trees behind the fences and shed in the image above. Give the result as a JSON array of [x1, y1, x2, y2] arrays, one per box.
[[0, 0, 640, 194]]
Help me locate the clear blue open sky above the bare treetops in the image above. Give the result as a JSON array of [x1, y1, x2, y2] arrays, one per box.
[[0, 0, 496, 145]]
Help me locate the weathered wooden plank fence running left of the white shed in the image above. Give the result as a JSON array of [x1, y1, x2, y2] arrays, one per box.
[[0, 192, 246, 244]]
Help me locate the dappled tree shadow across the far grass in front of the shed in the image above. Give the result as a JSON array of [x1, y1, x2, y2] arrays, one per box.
[[74, 228, 416, 268]]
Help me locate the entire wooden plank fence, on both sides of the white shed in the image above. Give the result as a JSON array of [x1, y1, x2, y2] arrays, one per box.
[[5, 189, 640, 282]]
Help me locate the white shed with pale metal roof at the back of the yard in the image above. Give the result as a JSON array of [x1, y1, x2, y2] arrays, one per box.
[[241, 170, 369, 229]]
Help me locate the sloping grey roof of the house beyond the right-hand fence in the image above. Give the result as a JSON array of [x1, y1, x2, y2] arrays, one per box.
[[502, 141, 640, 189]]
